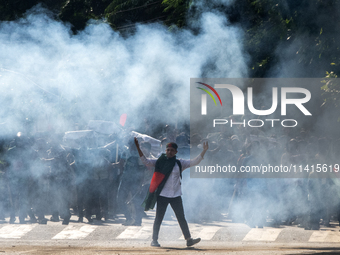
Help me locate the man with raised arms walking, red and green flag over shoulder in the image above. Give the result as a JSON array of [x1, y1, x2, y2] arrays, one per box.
[[135, 138, 209, 247]]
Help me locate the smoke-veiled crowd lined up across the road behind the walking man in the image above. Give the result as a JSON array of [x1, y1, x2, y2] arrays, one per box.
[[0, 121, 340, 229]]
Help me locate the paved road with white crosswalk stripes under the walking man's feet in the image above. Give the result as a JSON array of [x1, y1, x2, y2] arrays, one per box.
[[0, 212, 340, 254]]
